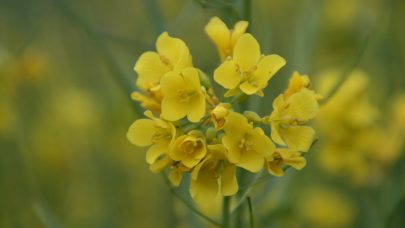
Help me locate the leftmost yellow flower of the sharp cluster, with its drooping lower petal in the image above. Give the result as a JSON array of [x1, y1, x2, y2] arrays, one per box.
[[127, 111, 176, 172]]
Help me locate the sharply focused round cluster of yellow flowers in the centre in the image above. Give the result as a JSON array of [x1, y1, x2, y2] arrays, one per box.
[[127, 17, 319, 203]]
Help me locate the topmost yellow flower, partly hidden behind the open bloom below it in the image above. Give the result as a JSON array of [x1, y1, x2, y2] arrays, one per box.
[[205, 17, 249, 61]]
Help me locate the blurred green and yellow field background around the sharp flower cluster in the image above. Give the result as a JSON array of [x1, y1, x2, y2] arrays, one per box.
[[0, 0, 405, 227]]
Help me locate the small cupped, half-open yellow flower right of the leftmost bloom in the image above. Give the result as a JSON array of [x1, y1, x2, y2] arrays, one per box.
[[169, 130, 207, 168]]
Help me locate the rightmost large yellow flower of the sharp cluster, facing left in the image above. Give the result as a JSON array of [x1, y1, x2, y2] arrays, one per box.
[[267, 90, 319, 152]]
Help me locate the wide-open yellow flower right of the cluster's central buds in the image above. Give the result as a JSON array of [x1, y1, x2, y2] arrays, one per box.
[[222, 112, 275, 173]]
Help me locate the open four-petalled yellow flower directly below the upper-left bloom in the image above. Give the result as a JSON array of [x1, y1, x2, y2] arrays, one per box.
[[161, 67, 206, 122]]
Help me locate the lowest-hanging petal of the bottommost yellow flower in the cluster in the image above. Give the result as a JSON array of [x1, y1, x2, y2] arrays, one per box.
[[190, 170, 219, 204]]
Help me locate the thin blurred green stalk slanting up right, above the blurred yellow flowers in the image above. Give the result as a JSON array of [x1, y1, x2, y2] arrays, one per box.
[[321, 33, 370, 104]]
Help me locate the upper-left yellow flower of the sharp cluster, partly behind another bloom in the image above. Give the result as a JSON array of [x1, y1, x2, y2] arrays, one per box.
[[134, 32, 192, 90]]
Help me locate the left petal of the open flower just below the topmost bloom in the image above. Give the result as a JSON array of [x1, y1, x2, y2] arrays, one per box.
[[214, 60, 241, 89]]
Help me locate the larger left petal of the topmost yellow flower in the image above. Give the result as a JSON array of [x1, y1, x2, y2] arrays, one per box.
[[205, 17, 231, 50]]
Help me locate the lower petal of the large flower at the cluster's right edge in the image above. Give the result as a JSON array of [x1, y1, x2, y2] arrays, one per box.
[[280, 126, 315, 152]]
